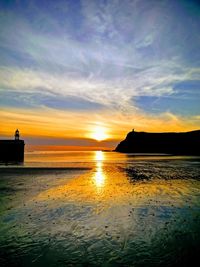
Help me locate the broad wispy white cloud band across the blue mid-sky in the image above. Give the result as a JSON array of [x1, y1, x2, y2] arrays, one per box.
[[0, 63, 197, 112]]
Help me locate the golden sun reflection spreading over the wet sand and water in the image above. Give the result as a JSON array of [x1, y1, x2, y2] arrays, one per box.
[[33, 151, 198, 206]]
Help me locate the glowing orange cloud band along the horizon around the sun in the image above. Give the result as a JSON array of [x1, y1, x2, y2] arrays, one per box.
[[0, 108, 200, 149]]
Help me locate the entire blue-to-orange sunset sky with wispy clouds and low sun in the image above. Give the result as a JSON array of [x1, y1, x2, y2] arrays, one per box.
[[0, 0, 200, 147]]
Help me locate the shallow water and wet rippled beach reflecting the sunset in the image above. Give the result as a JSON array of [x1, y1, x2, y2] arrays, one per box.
[[0, 151, 200, 267]]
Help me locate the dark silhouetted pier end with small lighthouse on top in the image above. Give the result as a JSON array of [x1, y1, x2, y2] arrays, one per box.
[[0, 129, 25, 163]]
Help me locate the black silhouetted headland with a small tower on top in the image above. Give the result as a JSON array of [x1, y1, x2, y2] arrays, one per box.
[[115, 130, 200, 155]]
